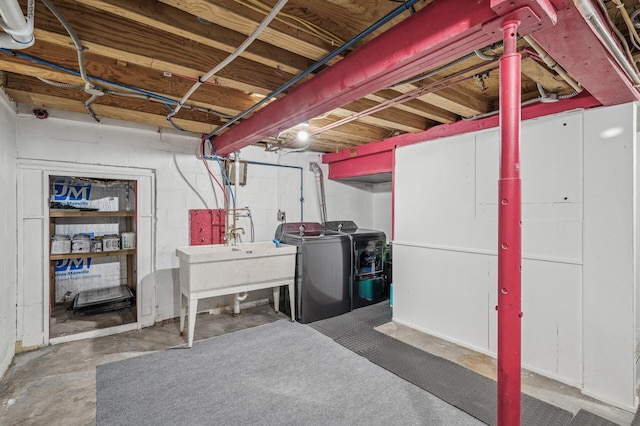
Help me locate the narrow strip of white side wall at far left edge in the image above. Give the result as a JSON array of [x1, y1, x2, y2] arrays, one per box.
[[0, 92, 17, 376]]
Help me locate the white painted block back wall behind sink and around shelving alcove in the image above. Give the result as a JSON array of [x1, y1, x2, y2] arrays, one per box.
[[15, 107, 372, 341]]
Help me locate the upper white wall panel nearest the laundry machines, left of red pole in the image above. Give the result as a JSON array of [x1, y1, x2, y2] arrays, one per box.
[[394, 135, 480, 248]]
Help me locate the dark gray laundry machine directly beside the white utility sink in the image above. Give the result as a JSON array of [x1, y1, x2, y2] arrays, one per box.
[[275, 222, 351, 323]]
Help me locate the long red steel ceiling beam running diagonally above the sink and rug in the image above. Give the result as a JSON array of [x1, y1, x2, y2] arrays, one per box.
[[213, 0, 557, 155]]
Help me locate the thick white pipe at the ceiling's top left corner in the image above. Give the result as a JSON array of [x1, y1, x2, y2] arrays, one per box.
[[0, 0, 35, 49]]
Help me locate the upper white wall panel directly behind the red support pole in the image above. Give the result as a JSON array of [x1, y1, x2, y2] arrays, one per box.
[[476, 112, 582, 262]]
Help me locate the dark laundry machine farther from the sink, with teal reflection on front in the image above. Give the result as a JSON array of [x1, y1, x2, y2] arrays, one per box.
[[324, 220, 389, 309]]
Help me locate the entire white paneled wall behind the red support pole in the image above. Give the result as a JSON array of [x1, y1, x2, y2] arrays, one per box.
[[393, 104, 637, 410]]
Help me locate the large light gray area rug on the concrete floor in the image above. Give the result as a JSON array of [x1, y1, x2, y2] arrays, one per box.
[[96, 320, 481, 426]]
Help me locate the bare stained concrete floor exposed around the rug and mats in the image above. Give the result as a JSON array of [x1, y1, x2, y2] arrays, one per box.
[[0, 305, 633, 426]]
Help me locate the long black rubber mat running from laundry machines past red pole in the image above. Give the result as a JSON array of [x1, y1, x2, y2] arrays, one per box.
[[308, 302, 616, 426]]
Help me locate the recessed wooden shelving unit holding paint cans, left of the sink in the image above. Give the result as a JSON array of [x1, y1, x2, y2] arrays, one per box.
[[47, 176, 137, 336]]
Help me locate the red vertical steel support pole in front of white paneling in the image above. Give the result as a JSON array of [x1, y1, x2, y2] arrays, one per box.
[[496, 21, 522, 426]]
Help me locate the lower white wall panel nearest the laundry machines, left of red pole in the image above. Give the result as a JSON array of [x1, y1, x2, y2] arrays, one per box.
[[393, 243, 490, 352]]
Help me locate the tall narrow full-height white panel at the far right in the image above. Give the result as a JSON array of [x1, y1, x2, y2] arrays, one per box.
[[583, 104, 637, 409]]
